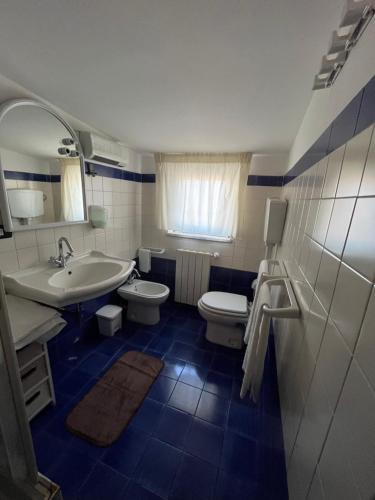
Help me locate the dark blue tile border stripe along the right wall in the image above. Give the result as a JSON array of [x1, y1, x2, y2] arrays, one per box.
[[283, 76, 375, 185]]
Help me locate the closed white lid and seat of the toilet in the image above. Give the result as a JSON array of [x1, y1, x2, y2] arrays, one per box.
[[199, 292, 248, 318]]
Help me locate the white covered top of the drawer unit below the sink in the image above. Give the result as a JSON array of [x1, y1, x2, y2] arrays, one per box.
[[6, 295, 66, 350]]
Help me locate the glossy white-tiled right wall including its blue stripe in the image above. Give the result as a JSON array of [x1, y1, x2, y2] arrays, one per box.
[[275, 76, 375, 500]]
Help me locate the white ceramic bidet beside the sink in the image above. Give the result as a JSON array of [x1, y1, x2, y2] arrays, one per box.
[[117, 280, 169, 325]]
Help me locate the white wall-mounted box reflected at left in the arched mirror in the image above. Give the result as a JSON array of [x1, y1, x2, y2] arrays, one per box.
[[7, 189, 44, 219]]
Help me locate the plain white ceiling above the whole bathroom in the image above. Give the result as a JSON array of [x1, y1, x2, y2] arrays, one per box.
[[0, 0, 344, 152]]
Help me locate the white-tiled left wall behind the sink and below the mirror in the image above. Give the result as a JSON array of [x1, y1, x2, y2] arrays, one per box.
[[0, 162, 142, 273]]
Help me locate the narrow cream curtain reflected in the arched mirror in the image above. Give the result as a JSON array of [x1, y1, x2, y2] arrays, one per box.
[[59, 158, 85, 221]]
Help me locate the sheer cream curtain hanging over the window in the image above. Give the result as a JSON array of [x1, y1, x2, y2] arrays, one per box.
[[155, 153, 251, 238]]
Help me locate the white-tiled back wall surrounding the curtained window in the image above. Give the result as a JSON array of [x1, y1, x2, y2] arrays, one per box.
[[142, 155, 285, 272]]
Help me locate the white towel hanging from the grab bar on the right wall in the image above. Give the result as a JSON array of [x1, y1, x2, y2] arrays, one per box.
[[240, 283, 271, 402]]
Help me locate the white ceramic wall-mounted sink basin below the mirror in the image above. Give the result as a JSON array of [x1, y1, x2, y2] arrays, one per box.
[[4, 252, 135, 307]]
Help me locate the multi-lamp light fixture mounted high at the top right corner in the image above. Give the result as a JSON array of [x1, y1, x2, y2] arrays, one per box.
[[313, 0, 375, 90]]
